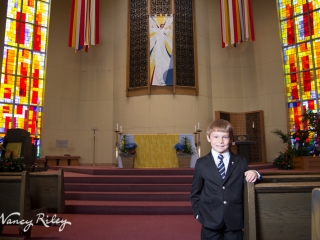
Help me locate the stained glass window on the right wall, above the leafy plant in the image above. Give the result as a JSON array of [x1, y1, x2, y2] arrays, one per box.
[[278, 0, 320, 131]]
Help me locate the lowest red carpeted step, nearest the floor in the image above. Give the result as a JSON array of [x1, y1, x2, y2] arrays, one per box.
[[65, 200, 192, 215]]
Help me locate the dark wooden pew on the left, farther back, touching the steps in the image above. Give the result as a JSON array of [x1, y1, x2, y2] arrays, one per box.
[[0, 169, 65, 213]]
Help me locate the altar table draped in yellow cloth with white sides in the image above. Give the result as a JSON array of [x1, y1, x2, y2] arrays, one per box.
[[118, 134, 198, 168]]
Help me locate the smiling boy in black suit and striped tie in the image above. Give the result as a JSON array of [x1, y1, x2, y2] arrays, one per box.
[[190, 119, 260, 240]]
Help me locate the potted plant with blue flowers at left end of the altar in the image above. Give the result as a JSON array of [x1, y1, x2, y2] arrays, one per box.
[[119, 135, 138, 168]]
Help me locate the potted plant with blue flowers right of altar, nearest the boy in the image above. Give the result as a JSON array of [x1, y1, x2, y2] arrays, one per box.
[[174, 137, 195, 168]]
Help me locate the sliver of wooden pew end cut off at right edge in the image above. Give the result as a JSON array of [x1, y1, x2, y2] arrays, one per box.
[[311, 188, 320, 240]]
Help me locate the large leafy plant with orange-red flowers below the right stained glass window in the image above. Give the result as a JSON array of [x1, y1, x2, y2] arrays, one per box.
[[272, 110, 320, 169]]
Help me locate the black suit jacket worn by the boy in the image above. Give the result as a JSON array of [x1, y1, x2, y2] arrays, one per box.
[[190, 152, 248, 230]]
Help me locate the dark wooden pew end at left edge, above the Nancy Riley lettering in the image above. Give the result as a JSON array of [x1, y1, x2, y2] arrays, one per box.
[[0, 171, 47, 237]]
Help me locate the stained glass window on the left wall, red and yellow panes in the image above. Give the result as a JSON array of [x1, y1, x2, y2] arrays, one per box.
[[0, 0, 50, 156]]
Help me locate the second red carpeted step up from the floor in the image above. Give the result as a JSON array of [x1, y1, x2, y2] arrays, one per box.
[[65, 192, 190, 201]]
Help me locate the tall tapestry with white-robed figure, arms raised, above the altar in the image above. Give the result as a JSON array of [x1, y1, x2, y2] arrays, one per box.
[[149, 15, 173, 86]]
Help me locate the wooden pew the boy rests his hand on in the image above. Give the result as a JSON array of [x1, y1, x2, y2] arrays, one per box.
[[244, 179, 320, 240]]
